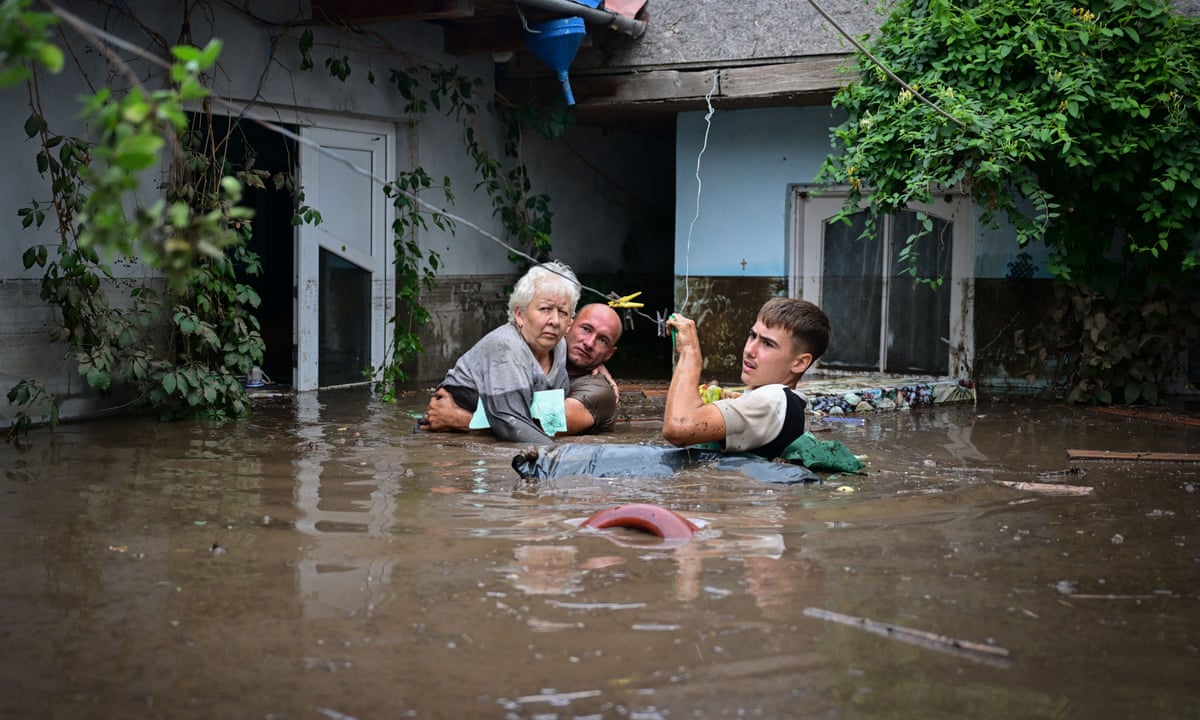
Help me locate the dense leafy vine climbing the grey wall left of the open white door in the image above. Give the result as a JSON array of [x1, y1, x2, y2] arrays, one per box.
[[7, 8, 263, 434]]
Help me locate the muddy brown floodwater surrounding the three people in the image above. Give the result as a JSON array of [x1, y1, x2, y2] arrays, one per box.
[[0, 391, 1200, 720]]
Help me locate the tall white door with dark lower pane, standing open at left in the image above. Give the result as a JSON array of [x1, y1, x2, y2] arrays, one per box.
[[295, 122, 395, 390]]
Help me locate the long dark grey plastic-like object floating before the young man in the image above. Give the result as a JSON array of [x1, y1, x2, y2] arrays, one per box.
[[512, 443, 821, 485]]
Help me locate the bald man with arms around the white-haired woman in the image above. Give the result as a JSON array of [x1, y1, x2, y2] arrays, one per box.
[[418, 302, 622, 434]]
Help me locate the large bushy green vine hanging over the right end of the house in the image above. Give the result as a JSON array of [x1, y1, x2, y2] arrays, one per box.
[[820, 0, 1200, 403]]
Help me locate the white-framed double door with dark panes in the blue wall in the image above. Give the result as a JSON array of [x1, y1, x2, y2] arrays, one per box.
[[791, 188, 974, 377]]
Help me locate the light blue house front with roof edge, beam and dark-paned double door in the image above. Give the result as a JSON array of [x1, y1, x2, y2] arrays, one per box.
[[509, 0, 1049, 389]]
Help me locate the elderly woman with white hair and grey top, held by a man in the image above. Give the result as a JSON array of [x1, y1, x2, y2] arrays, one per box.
[[419, 262, 580, 444]]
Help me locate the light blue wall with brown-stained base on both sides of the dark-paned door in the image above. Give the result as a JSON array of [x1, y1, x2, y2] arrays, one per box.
[[674, 107, 1049, 386]]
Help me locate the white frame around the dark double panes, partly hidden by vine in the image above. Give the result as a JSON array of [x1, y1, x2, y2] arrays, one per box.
[[787, 185, 976, 379]]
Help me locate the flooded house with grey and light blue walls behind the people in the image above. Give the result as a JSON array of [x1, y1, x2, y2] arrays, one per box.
[[0, 0, 1185, 425]]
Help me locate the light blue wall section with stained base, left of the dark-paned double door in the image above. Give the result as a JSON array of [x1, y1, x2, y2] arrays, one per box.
[[674, 107, 838, 383]]
